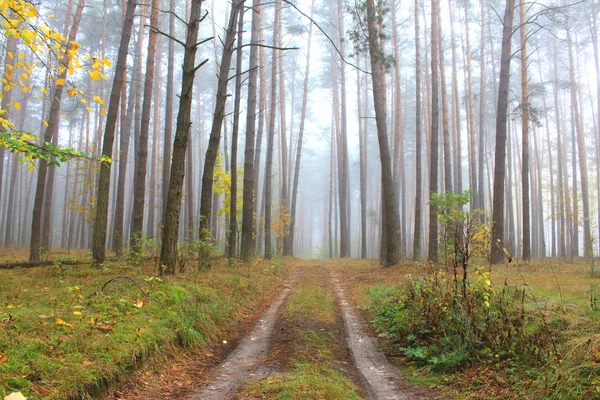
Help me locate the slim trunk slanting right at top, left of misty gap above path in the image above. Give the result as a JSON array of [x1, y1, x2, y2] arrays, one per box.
[[283, 0, 315, 256]]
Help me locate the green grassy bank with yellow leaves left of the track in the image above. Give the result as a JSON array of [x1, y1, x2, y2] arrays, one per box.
[[0, 256, 283, 399]]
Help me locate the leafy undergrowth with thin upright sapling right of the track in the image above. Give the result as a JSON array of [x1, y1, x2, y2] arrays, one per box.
[[368, 193, 600, 399]]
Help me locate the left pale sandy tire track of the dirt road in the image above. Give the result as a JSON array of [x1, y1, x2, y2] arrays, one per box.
[[191, 271, 296, 400]]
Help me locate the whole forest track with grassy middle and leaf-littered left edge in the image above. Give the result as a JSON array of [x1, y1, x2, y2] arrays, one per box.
[[104, 260, 439, 400]]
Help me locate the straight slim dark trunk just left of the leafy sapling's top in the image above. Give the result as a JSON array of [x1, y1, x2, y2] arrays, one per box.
[[427, 0, 440, 262]]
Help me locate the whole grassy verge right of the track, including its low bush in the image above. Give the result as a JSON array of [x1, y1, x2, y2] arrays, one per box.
[[357, 260, 600, 399]]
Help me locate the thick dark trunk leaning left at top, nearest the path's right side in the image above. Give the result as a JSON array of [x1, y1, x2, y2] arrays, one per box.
[[366, 0, 399, 266]]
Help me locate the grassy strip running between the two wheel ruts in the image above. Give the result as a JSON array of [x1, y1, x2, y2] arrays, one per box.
[[239, 274, 362, 400]]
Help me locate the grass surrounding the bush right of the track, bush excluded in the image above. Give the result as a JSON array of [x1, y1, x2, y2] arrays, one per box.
[[344, 259, 600, 399]]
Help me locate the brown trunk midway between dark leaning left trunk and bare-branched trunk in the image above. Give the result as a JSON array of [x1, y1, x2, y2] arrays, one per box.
[[130, 0, 159, 253]]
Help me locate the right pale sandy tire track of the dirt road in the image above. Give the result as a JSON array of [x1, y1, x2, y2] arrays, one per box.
[[330, 271, 429, 400]]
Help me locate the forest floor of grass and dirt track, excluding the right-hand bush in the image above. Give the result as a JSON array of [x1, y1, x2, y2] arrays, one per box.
[[0, 249, 600, 400]]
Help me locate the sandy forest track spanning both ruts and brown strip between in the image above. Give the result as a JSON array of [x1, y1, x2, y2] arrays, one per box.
[[191, 262, 434, 400]]
